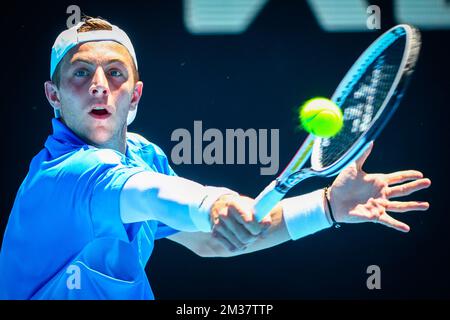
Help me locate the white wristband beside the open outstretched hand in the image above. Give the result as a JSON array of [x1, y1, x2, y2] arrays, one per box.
[[280, 189, 331, 240]]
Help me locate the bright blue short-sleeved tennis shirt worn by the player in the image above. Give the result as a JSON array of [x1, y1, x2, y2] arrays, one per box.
[[0, 119, 177, 299]]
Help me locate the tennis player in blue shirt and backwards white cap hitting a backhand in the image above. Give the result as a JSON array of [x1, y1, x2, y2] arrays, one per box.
[[0, 18, 431, 299]]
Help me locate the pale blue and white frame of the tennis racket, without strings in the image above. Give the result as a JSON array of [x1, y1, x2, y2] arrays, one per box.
[[254, 24, 421, 221]]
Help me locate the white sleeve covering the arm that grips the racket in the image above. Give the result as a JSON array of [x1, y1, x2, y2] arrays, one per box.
[[120, 171, 237, 232]]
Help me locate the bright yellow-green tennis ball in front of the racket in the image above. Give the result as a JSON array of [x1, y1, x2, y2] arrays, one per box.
[[300, 98, 344, 138]]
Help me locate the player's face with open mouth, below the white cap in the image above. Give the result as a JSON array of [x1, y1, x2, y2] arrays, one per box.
[[48, 41, 142, 148]]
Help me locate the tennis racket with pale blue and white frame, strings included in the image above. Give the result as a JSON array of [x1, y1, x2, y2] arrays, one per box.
[[254, 24, 421, 221]]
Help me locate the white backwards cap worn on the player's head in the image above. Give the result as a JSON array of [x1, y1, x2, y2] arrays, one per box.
[[50, 21, 138, 125]]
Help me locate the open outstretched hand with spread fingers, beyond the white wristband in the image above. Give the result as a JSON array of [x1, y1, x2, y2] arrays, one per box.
[[329, 142, 431, 232]]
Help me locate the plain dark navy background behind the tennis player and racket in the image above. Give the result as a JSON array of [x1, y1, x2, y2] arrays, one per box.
[[0, 0, 450, 299]]
